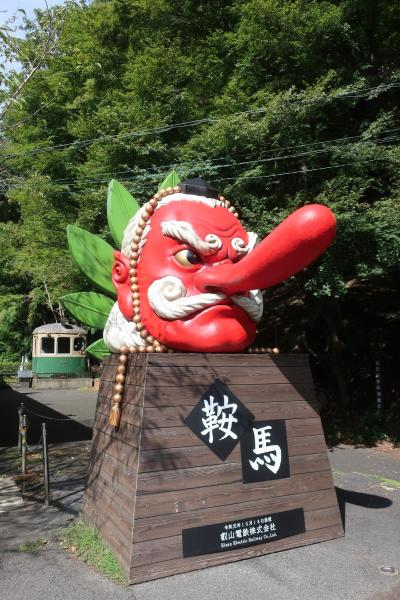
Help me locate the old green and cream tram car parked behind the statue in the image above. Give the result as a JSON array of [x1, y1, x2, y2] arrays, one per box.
[[32, 323, 87, 378]]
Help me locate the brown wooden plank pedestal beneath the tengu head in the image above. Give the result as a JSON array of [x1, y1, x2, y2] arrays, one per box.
[[84, 354, 343, 583]]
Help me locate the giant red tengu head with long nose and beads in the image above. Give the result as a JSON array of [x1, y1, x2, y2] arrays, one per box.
[[104, 180, 336, 352]]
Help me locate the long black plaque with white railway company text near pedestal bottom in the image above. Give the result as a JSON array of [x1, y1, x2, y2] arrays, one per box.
[[182, 508, 305, 557]]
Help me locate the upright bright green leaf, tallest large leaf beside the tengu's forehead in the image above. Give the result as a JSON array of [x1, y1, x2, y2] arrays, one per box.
[[107, 179, 140, 248]]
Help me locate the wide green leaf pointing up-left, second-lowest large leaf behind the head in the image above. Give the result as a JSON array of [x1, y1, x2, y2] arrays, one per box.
[[67, 225, 115, 297]]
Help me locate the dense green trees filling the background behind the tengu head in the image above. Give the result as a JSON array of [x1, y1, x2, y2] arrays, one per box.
[[0, 0, 400, 412]]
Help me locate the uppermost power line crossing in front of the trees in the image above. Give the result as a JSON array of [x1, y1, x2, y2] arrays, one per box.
[[3, 83, 400, 158]]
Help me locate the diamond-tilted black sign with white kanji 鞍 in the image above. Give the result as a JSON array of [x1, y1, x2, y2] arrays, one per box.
[[184, 379, 254, 460]]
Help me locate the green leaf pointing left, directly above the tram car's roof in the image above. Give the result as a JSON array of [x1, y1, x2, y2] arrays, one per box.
[[61, 292, 114, 329]]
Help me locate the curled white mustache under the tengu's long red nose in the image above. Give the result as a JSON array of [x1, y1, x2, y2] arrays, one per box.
[[147, 275, 263, 322]]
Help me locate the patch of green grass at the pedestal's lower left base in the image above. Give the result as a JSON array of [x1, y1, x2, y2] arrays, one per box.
[[62, 519, 127, 585]]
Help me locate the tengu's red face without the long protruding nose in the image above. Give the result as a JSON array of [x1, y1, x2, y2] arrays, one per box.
[[137, 200, 256, 352]]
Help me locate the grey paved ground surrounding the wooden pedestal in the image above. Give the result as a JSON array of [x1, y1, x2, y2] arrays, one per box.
[[0, 392, 400, 600]]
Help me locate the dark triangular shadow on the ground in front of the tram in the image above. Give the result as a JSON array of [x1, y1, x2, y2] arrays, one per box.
[[0, 387, 92, 447]]
